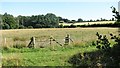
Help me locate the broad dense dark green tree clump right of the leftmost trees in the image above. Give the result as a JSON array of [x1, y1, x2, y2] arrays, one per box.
[[18, 13, 59, 28]]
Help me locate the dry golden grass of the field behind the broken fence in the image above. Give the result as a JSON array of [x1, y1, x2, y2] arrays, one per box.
[[1, 27, 118, 46]]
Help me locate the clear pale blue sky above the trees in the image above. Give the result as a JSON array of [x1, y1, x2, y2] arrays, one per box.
[[0, 0, 118, 20]]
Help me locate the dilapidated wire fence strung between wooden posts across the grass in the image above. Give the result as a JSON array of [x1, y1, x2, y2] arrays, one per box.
[[2, 36, 73, 47]]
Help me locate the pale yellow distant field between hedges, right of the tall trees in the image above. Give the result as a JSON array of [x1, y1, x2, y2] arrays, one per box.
[[59, 21, 115, 26]]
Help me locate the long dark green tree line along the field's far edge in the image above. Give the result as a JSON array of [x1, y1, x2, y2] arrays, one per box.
[[0, 13, 114, 29]]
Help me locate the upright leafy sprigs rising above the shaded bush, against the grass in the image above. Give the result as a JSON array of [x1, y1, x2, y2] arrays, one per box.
[[96, 32, 120, 52]]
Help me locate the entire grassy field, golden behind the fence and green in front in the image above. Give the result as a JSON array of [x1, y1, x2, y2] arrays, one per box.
[[1, 28, 118, 66]]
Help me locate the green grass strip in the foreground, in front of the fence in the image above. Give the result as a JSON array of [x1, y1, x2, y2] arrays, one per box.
[[2, 46, 96, 66]]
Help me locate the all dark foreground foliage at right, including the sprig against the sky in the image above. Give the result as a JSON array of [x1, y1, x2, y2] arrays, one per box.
[[68, 7, 120, 68]]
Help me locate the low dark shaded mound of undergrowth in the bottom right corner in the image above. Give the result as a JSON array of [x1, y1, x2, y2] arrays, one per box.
[[68, 50, 120, 68]]
